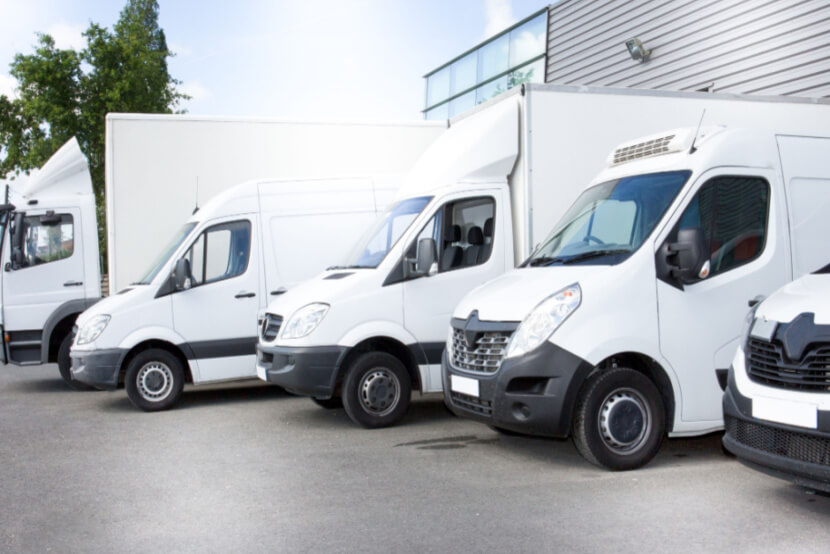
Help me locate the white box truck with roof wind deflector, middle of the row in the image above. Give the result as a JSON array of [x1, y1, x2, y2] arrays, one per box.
[[257, 85, 830, 428]]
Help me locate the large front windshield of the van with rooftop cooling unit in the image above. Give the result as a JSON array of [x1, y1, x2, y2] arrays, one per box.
[[522, 171, 692, 266]]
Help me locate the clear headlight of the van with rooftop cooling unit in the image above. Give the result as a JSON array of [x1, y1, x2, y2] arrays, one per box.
[[505, 283, 582, 358]]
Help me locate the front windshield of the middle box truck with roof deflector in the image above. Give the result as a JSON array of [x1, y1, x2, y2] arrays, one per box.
[[332, 196, 432, 269]]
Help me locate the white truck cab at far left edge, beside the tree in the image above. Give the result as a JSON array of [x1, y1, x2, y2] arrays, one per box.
[[0, 138, 101, 389]]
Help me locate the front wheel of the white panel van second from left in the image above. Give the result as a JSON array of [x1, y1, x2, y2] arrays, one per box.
[[124, 348, 184, 412]]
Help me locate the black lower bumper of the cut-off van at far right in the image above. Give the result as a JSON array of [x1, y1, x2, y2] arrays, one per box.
[[723, 371, 830, 492]]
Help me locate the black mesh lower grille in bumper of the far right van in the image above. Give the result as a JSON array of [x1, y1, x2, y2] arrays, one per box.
[[724, 416, 830, 466]]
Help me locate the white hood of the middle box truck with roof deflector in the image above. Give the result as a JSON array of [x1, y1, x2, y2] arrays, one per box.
[[266, 268, 379, 318]]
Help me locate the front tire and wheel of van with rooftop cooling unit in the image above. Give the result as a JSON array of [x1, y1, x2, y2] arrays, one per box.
[[573, 368, 666, 471]]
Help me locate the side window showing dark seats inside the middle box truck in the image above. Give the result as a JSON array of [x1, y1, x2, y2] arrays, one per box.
[[420, 197, 495, 273]]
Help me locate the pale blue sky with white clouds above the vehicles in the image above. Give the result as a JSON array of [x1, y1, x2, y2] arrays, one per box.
[[0, 0, 550, 121]]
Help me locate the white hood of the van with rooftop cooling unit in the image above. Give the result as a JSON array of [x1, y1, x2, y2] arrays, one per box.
[[453, 264, 608, 321]]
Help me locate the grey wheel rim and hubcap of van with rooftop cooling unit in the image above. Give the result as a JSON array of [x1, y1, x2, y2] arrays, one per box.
[[599, 389, 652, 454]]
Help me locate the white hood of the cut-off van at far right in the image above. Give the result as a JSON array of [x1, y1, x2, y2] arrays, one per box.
[[755, 273, 830, 325]]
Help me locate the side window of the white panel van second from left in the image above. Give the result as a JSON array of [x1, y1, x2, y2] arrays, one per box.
[[185, 221, 251, 286]]
